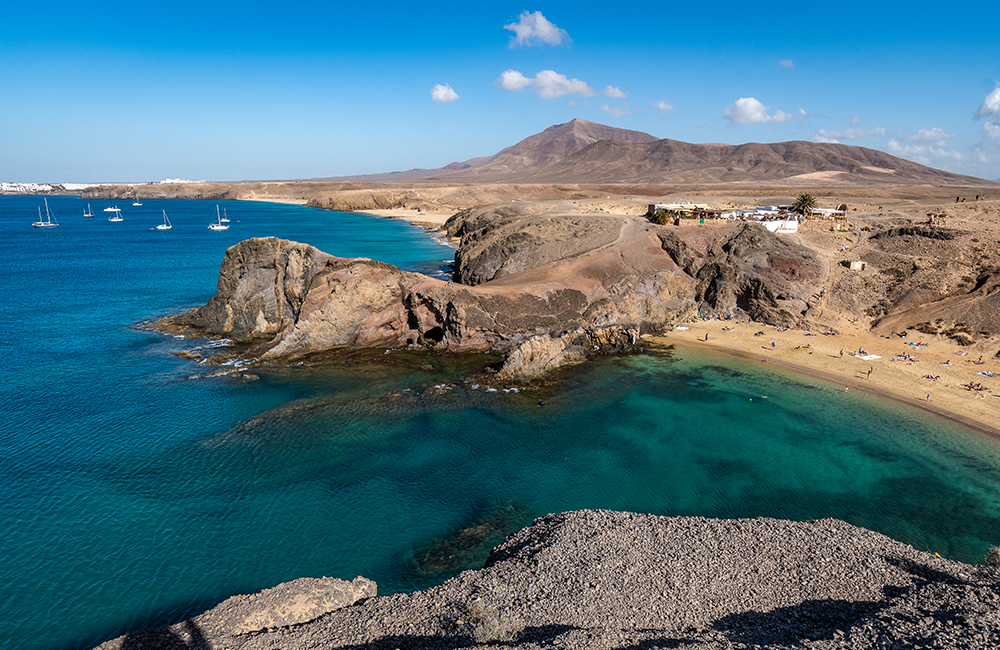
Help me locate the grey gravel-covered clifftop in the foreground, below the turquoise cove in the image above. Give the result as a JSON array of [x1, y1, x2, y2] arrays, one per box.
[[100, 511, 1000, 650]]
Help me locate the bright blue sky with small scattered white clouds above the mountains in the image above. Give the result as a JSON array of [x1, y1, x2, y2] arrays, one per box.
[[0, 0, 1000, 182]]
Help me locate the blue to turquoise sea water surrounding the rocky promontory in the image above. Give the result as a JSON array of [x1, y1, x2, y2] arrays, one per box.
[[0, 196, 1000, 649]]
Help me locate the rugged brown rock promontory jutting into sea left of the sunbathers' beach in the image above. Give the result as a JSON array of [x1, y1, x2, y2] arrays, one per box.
[[162, 207, 826, 377]]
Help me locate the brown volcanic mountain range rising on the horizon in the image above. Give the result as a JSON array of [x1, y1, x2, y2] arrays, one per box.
[[423, 119, 989, 185]]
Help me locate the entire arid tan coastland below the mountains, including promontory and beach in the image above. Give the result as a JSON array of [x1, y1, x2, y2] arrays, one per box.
[[145, 177, 1000, 431]]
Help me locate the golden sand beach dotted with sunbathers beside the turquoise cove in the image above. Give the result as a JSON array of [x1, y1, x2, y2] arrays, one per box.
[[649, 320, 1000, 438]]
